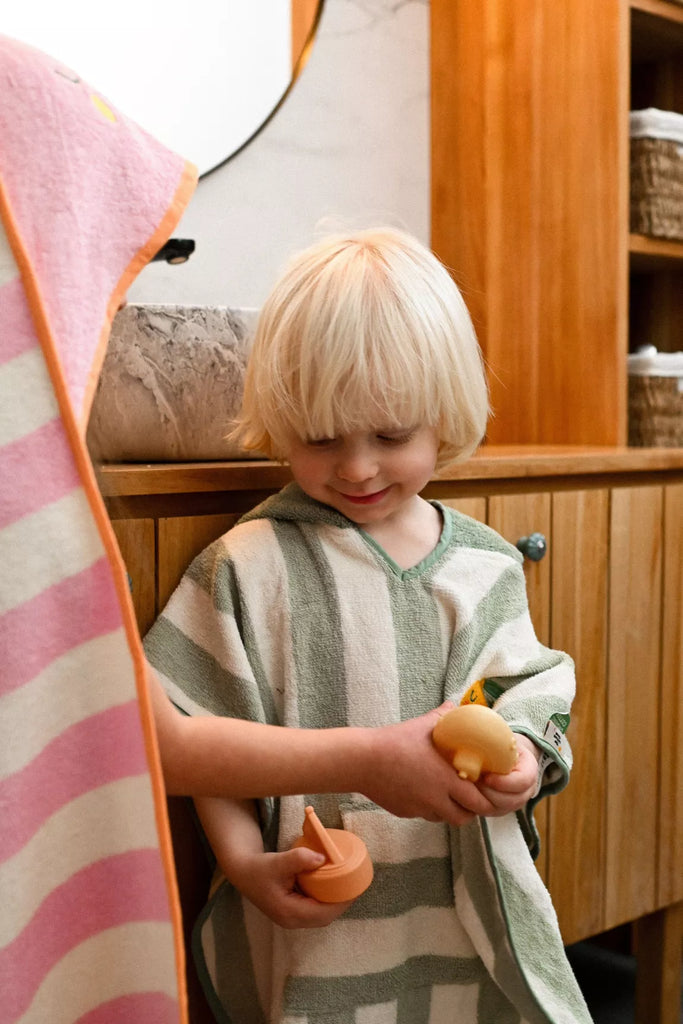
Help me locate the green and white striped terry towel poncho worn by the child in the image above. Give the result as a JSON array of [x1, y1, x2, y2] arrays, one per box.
[[145, 484, 590, 1024]]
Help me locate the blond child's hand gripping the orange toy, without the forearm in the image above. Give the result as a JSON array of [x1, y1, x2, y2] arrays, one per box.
[[230, 847, 353, 928]]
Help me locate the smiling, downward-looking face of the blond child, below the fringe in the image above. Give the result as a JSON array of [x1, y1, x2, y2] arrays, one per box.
[[286, 424, 438, 525]]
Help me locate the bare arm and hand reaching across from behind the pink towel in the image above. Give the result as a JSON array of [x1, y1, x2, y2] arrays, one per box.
[[150, 671, 488, 825]]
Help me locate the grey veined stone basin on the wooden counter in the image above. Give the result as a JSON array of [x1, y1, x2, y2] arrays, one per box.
[[87, 304, 256, 462]]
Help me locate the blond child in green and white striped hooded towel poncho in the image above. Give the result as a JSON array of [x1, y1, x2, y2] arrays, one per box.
[[145, 229, 590, 1024]]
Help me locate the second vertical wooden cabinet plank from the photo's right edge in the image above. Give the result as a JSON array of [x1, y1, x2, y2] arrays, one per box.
[[605, 486, 663, 928]]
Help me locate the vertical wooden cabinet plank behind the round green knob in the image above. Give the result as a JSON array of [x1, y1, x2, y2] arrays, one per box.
[[488, 493, 552, 882]]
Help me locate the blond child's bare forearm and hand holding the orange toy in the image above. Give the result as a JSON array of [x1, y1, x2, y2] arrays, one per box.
[[195, 797, 350, 928]]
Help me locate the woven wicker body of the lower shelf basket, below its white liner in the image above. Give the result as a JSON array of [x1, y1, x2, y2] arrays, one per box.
[[629, 375, 683, 447]]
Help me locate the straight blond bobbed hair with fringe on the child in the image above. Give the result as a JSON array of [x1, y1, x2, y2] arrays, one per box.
[[231, 228, 488, 465]]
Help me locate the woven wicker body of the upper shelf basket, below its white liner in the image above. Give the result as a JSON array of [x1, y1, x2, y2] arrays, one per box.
[[631, 138, 683, 241]]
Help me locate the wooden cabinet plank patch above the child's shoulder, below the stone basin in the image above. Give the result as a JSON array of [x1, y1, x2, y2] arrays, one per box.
[[157, 512, 240, 611]]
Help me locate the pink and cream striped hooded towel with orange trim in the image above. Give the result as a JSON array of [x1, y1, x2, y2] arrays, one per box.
[[0, 37, 196, 1024]]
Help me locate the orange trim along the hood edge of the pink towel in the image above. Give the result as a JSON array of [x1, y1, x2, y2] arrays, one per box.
[[79, 160, 198, 434]]
